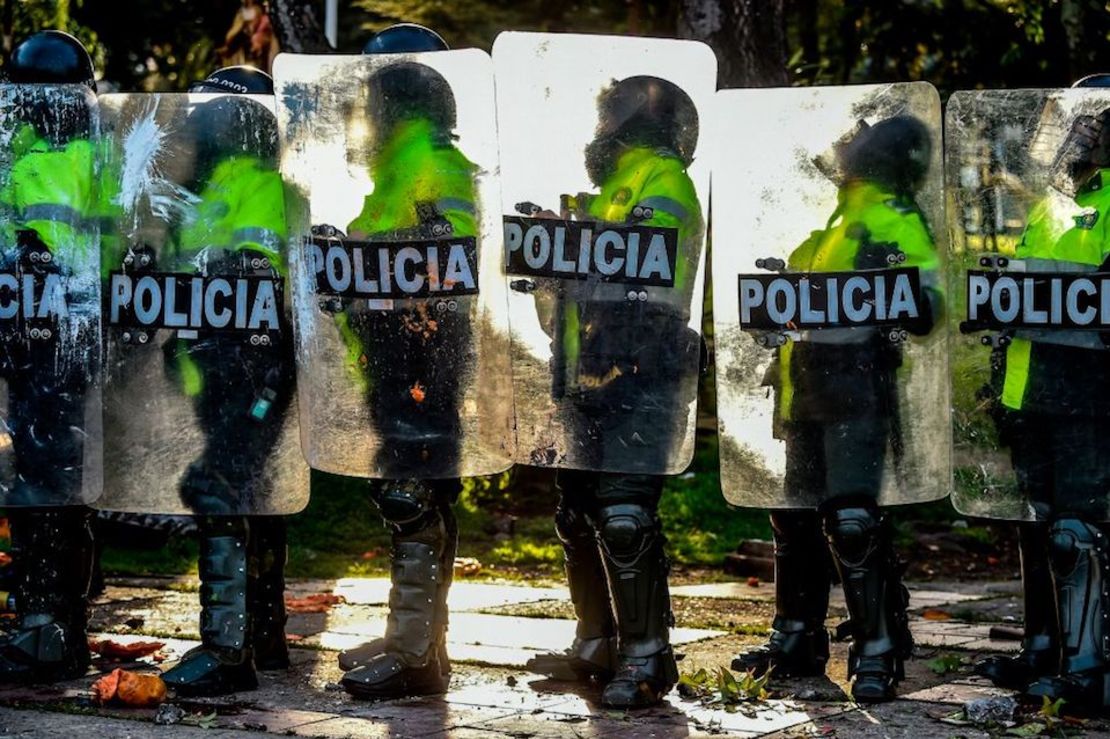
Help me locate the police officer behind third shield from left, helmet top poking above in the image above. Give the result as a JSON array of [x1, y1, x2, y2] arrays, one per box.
[[336, 23, 466, 698]]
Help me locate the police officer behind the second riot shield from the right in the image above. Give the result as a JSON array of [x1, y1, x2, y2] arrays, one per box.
[[733, 115, 942, 702]]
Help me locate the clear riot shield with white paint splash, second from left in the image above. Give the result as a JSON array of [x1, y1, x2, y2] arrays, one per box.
[[99, 93, 309, 515]]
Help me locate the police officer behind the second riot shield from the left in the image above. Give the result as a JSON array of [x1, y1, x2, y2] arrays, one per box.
[[164, 67, 294, 695]]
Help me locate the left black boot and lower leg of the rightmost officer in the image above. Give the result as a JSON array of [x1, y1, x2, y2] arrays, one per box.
[[975, 522, 1060, 690]]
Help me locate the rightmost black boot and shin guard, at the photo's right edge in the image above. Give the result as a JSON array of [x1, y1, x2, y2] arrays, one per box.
[[1026, 518, 1110, 710]]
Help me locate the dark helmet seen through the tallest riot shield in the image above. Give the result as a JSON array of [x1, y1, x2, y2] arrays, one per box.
[[586, 74, 698, 186]]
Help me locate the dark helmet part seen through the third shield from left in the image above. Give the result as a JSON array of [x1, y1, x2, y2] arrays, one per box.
[[367, 61, 455, 135]]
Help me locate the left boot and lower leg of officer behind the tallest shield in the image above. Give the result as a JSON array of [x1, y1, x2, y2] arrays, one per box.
[[525, 500, 617, 682]]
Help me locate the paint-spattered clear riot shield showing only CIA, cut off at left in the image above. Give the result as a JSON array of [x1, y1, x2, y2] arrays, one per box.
[[0, 84, 101, 507]]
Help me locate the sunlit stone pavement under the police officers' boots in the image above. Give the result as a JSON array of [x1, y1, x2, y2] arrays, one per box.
[[0, 578, 1110, 739]]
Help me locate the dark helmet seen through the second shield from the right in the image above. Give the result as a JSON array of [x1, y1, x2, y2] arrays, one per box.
[[838, 114, 932, 195]]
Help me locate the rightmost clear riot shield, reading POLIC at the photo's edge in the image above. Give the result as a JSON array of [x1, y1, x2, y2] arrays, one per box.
[[946, 89, 1110, 520]]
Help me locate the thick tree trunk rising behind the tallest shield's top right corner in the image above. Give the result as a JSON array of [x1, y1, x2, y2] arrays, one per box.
[[678, 0, 789, 88]]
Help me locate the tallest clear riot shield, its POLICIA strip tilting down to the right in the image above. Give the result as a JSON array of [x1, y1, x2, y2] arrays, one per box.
[[493, 32, 717, 474]]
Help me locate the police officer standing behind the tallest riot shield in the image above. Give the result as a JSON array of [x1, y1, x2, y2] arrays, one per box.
[[528, 75, 704, 708]]
